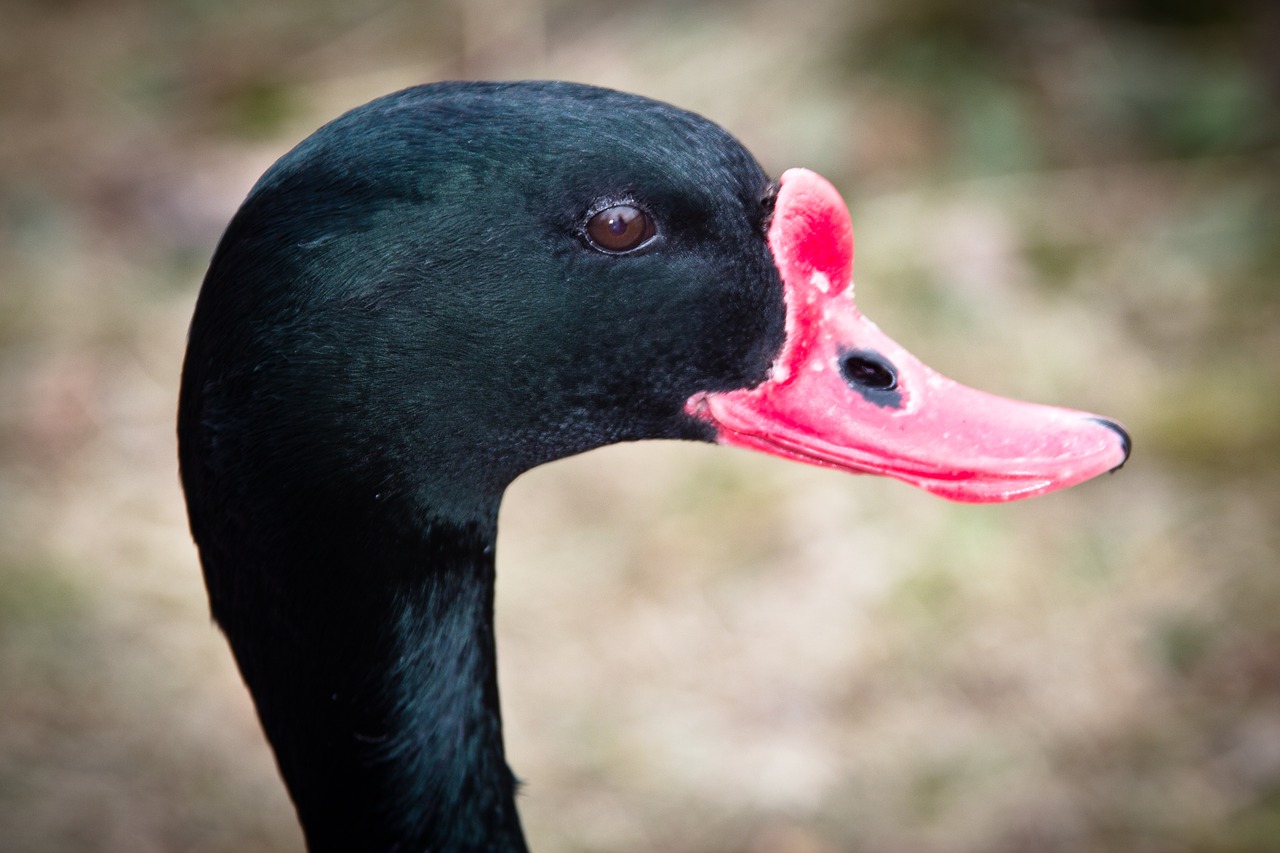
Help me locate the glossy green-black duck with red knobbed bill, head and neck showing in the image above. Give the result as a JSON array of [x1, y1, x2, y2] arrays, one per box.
[[178, 82, 1129, 850]]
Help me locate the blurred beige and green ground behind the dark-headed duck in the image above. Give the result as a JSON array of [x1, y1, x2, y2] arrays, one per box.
[[0, 0, 1280, 853]]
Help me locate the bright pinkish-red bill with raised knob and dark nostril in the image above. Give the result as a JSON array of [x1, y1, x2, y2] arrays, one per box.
[[686, 169, 1129, 502]]
